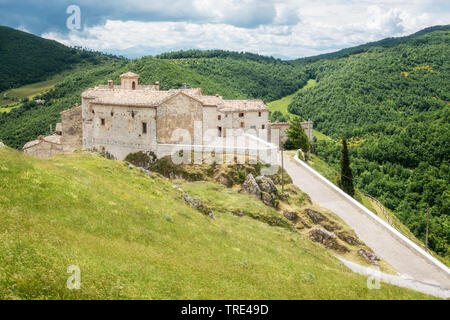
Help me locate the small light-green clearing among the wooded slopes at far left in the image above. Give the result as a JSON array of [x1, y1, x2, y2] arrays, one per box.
[[0, 74, 64, 112]]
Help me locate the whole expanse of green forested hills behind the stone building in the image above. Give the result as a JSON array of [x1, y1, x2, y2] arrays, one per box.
[[0, 26, 450, 258]]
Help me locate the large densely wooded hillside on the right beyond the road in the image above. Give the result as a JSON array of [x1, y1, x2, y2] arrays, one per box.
[[289, 26, 450, 256]]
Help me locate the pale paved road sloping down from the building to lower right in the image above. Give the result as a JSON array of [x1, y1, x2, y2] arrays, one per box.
[[284, 155, 450, 289]]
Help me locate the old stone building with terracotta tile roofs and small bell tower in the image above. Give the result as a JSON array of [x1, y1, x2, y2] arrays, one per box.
[[24, 72, 312, 160]]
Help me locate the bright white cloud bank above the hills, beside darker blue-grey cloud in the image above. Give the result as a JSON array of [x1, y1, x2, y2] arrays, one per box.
[[43, 0, 450, 58]]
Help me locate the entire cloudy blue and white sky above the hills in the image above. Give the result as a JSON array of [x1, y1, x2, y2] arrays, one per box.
[[0, 0, 450, 59]]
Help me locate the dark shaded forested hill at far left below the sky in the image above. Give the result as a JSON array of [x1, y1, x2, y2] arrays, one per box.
[[0, 26, 116, 92]]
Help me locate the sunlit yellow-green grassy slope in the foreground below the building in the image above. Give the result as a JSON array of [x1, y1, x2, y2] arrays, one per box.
[[0, 148, 428, 299]]
